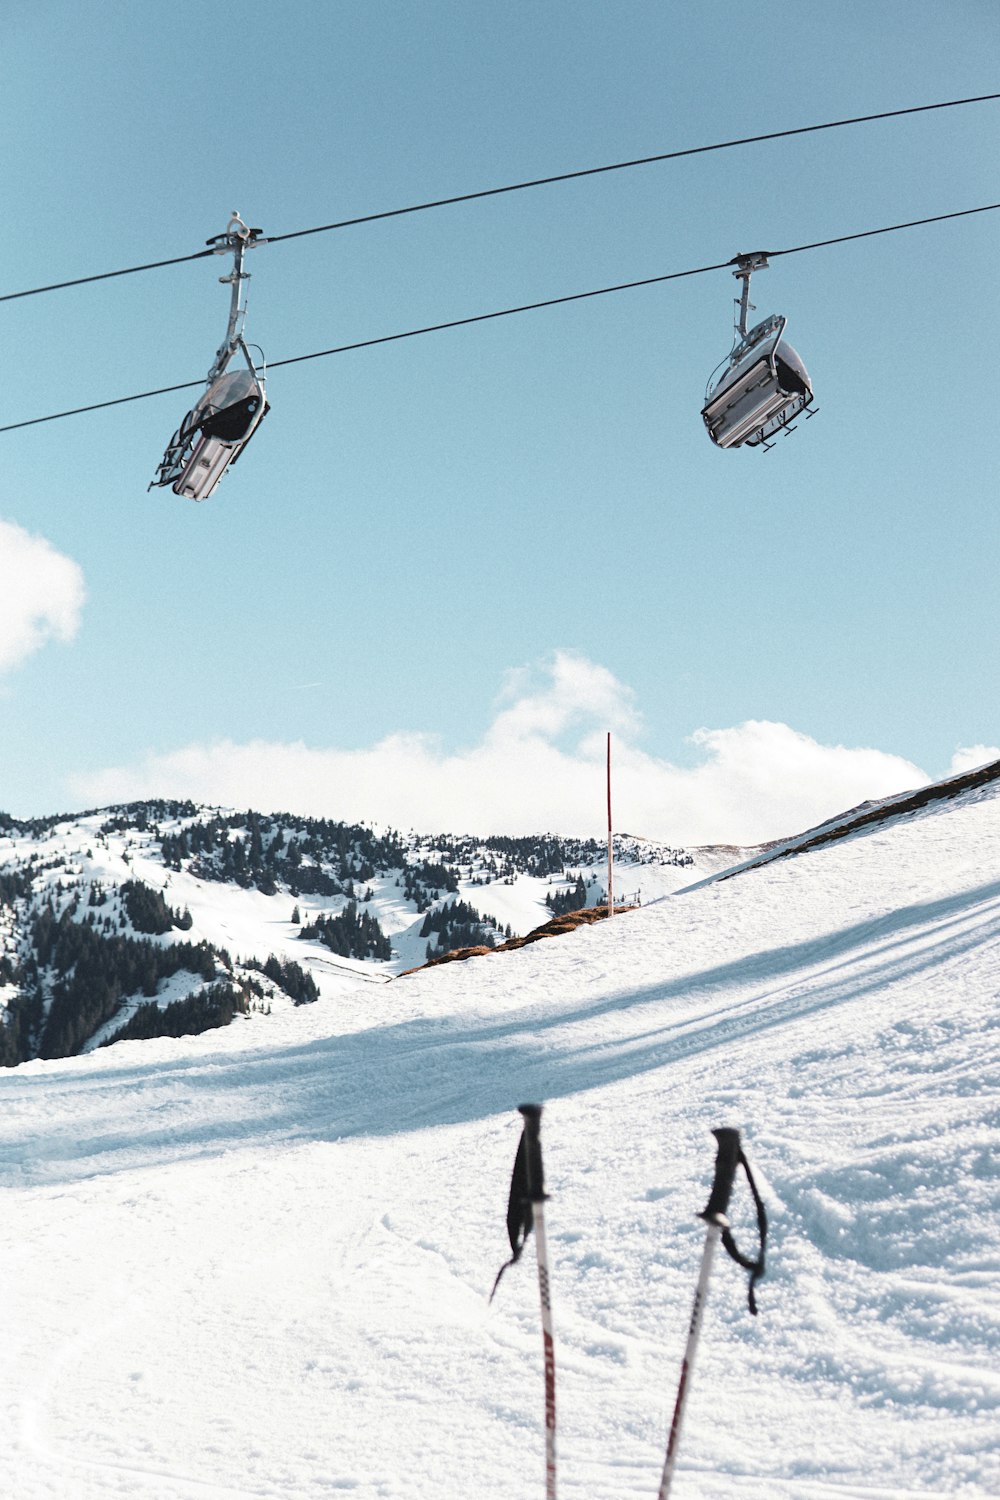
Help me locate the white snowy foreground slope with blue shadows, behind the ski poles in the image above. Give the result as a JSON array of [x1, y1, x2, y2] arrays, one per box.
[[0, 783, 1000, 1500]]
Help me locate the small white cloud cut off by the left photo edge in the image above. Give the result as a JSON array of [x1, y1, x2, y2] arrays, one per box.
[[0, 521, 85, 672]]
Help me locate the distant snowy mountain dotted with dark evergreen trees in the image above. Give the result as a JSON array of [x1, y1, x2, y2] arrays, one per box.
[[0, 803, 704, 1067]]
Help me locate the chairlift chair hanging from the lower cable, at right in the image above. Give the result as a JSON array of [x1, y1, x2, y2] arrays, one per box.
[[702, 252, 813, 449]]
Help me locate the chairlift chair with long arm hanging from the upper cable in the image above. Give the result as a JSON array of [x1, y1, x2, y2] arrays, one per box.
[[148, 213, 270, 500]]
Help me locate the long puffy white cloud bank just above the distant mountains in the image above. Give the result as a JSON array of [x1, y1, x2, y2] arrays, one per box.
[[73, 651, 928, 846]]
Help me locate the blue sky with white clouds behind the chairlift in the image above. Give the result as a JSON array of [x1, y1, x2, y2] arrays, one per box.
[[0, 0, 1000, 842]]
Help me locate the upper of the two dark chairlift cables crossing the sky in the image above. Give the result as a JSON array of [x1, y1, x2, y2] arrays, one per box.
[[0, 93, 1000, 306]]
